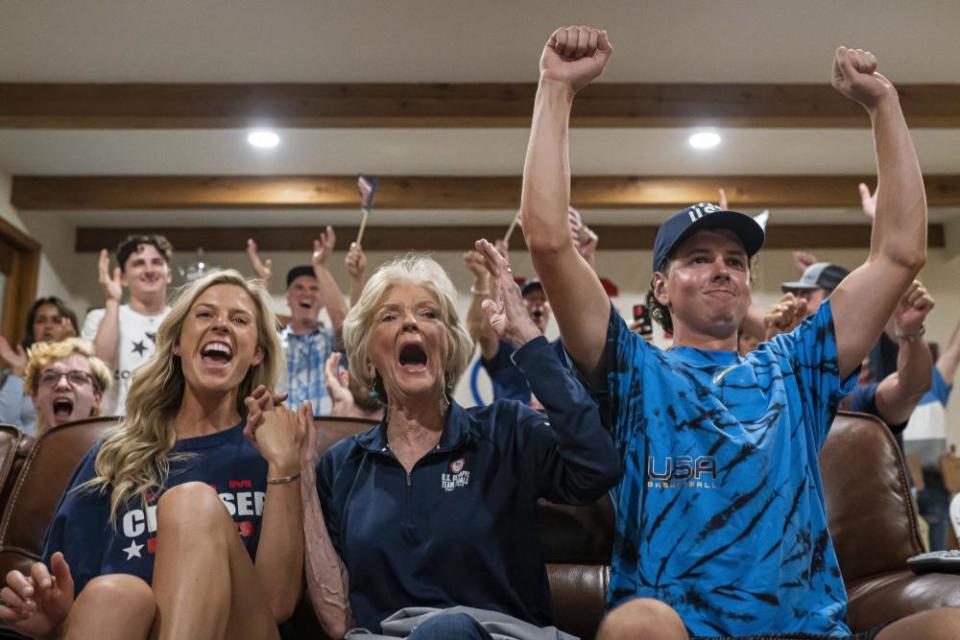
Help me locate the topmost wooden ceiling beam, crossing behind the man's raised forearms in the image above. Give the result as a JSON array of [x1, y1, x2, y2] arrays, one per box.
[[0, 83, 960, 129]]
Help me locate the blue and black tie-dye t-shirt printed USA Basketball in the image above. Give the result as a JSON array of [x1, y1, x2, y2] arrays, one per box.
[[606, 301, 856, 637]]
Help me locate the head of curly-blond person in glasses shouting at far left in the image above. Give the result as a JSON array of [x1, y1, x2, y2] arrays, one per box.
[[23, 338, 113, 435]]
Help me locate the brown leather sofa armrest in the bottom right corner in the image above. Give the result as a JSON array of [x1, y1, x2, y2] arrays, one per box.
[[847, 569, 960, 631]]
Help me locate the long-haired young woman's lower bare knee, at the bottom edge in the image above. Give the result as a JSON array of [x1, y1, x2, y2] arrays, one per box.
[[63, 573, 156, 640]]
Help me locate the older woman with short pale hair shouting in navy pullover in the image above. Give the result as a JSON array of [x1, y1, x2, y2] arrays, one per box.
[[303, 241, 620, 639]]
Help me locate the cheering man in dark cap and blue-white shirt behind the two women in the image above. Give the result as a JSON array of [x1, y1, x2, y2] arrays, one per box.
[[247, 226, 347, 416]]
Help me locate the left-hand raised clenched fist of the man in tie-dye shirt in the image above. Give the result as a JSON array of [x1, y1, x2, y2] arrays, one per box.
[[540, 27, 613, 91]]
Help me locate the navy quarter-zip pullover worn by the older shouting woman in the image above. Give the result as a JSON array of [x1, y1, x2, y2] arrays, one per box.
[[317, 337, 620, 632]]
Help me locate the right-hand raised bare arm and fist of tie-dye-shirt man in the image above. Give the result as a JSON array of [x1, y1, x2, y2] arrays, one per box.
[[830, 47, 927, 377]]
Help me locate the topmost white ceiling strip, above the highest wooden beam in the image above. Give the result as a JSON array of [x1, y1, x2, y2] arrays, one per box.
[[0, 0, 960, 82]]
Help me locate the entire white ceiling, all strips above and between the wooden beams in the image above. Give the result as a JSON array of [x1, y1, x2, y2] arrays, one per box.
[[0, 0, 960, 226]]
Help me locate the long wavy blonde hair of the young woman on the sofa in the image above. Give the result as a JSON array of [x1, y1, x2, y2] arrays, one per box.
[[79, 270, 283, 524]]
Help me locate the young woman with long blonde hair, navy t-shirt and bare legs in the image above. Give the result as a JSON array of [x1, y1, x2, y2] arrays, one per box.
[[0, 271, 303, 640]]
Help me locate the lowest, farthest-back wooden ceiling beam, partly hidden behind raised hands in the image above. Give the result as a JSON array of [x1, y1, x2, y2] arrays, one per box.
[[75, 224, 944, 254]]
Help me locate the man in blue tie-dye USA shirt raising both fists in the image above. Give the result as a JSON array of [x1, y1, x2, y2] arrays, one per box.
[[521, 27, 960, 640]]
